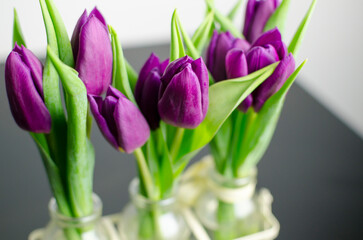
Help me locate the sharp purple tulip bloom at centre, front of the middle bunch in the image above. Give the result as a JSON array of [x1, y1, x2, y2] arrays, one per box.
[[158, 56, 209, 128]]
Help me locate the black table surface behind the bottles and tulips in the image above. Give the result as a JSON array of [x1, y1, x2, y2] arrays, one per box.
[[0, 45, 363, 240]]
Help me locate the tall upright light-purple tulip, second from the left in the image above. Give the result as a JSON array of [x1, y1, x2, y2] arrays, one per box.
[[71, 8, 112, 95]]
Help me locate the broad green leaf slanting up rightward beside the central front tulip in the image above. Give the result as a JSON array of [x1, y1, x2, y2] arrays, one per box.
[[176, 63, 278, 172]]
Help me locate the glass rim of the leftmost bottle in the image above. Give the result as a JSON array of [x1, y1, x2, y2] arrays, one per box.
[[48, 193, 103, 228]]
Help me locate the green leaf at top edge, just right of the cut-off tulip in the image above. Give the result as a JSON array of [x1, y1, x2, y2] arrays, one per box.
[[264, 0, 290, 35]]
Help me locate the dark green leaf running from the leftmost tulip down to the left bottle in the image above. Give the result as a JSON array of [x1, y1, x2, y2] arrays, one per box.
[[30, 133, 72, 217]]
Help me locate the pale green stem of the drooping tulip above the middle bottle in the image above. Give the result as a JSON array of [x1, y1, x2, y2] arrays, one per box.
[[134, 148, 154, 199]]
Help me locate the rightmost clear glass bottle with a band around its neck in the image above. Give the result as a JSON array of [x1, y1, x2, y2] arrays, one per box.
[[195, 168, 263, 240]]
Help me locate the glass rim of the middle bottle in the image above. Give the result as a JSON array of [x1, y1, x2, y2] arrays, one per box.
[[129, 178, 176, 209]]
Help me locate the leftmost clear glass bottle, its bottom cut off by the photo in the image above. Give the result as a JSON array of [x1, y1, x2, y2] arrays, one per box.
[[42, 194, 114, 240]]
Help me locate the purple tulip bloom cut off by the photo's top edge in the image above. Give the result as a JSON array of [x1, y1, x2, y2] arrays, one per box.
[[243, 0, 281, 43]]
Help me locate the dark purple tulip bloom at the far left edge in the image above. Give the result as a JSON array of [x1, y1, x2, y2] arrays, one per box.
[[5, 44, 52, 133]]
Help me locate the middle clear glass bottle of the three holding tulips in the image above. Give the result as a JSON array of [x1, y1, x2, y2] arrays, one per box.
[[119, 179, 190, 240]]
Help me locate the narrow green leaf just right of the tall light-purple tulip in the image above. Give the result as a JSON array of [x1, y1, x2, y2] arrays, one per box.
[[108, 26, 137, 106]]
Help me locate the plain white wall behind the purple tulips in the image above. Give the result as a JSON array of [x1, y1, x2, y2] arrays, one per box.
[[0, 0, 363, 137]]
